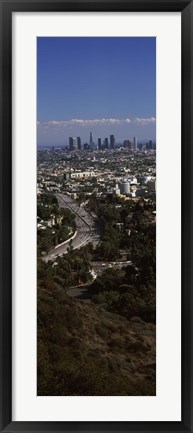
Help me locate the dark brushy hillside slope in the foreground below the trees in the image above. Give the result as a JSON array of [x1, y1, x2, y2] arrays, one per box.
[[38, 279, 156, 396]]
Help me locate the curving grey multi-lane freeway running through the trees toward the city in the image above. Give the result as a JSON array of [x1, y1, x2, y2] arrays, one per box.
[[44, 194, 100, 262]]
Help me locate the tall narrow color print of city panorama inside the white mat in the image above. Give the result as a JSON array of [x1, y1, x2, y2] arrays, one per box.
[[37, 37, 156, 397]]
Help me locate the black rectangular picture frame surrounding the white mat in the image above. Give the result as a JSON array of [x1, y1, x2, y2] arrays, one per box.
[[0, 0, 193, 433]]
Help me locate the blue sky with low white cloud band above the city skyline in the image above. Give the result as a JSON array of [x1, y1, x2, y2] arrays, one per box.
[[37, 37, 156, 145]]
